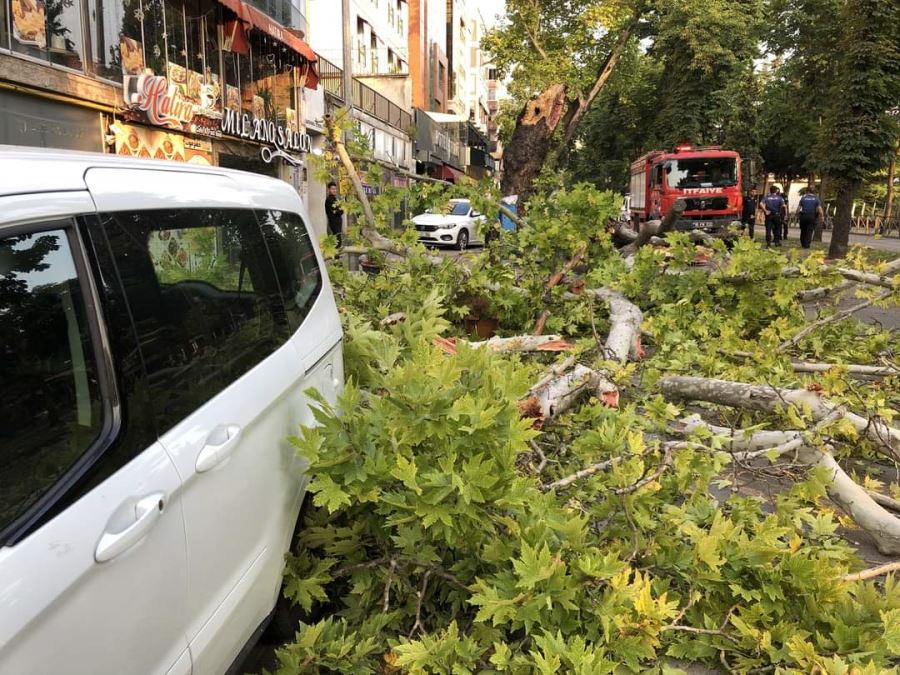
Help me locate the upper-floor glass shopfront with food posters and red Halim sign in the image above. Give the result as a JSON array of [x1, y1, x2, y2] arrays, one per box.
[[0, 0, 306, 128]]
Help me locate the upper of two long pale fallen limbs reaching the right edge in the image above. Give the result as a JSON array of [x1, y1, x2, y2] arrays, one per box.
[[659, 376, 900, 460]]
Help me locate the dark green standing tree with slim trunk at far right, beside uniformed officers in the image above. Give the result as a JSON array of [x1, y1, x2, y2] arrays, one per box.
[[815, 0, 900, 258]]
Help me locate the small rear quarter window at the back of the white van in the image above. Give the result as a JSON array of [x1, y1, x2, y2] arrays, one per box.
[[257, 211, 322, 330]]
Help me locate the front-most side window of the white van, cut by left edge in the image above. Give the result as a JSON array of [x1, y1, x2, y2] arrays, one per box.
[[0, 229, 103, 530]]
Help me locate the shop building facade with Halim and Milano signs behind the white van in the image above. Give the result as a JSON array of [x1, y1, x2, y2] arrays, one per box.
[[0, 0, 318, 217]]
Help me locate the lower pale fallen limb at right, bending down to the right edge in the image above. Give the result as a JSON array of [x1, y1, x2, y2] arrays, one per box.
[[686, 418, 900, 555]]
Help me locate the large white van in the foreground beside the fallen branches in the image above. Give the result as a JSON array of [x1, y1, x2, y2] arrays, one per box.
[[0, 146, 343, 675]]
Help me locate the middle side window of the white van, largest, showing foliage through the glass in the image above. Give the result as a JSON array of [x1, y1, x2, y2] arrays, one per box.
[[104, 209, 291, 433]]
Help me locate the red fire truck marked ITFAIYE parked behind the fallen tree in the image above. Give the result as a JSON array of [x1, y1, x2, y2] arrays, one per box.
[[631, 144, 742, 232]]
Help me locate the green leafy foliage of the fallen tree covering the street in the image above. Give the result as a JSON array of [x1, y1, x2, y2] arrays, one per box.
[[270, 210, 900, 674]]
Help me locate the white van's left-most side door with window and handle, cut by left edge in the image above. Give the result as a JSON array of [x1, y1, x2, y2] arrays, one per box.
[[0, 211, 191, 675]]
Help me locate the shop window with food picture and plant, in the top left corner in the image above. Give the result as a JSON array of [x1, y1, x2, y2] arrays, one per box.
[[9, 0, 84, 70]]
